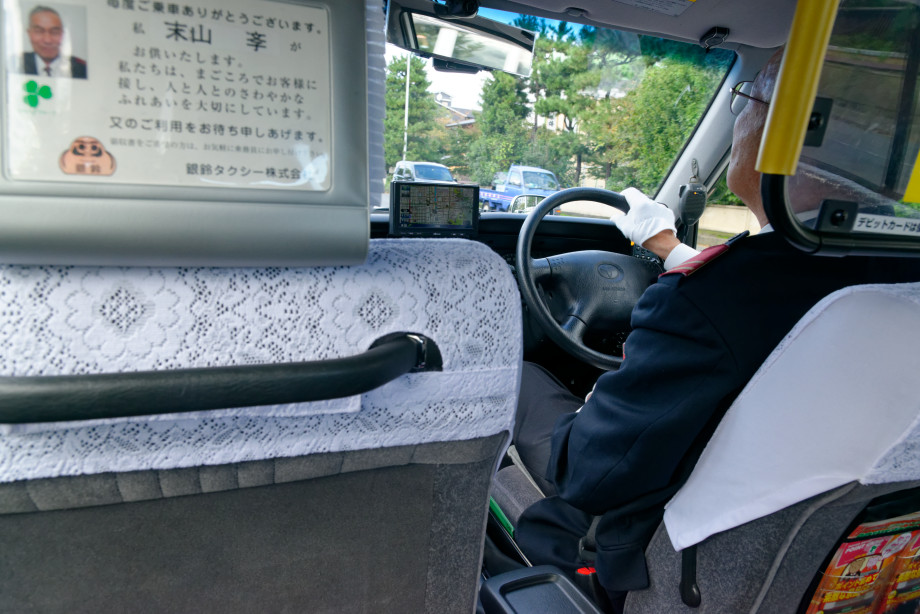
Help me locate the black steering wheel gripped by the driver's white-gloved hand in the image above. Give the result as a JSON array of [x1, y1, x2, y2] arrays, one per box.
[[515, 188, 662, 370]]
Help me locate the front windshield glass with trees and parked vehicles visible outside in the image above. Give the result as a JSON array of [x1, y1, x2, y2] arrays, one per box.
[[381, 9, 734, 218]]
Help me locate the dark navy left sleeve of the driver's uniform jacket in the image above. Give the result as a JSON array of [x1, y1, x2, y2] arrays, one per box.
[[549, 275, 743, 514]]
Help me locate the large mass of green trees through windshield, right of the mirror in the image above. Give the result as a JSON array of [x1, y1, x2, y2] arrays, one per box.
[[438, 24, 734, 192]]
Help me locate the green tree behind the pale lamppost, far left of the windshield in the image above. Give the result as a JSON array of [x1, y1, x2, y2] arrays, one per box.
[[384, 56, 447, 169]]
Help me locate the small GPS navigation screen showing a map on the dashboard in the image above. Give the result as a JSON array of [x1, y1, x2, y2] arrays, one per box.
[[390, 181, 479, 237]]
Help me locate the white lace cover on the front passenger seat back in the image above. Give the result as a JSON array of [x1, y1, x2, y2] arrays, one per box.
[[0, 239, 522, 482]]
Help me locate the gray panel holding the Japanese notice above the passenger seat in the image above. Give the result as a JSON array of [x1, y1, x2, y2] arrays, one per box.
[[0, 0, 374, 266]]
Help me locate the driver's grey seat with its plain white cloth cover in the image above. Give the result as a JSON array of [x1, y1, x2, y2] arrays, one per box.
[[492, 283, 920, 614]]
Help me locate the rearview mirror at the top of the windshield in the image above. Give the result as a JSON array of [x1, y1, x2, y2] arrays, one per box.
[[387, 0, 536, 77]]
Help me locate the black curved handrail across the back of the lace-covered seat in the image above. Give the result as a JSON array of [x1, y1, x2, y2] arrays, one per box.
[[0, 333, 442, 424]]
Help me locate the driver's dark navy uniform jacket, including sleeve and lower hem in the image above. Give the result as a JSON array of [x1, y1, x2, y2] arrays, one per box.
[[515, 233, 920, 591]]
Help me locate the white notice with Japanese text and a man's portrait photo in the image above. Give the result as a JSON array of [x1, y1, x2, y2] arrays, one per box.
[[2, 0, 332, 191]]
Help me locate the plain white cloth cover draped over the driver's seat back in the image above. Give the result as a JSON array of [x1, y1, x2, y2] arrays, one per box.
[[664, 283, 920, 550]]
